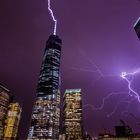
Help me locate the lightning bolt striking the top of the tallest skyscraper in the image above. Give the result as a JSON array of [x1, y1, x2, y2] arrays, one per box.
[[48, 0, 57, 35]]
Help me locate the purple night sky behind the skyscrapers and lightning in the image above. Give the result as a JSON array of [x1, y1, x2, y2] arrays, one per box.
[[0, 0, 140, 140]]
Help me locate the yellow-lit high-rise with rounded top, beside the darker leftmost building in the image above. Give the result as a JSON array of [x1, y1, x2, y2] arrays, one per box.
[[4, 102, 22, 140]]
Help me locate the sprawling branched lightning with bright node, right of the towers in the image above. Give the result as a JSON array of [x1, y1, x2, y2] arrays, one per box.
[[71, 49, 140, 117]]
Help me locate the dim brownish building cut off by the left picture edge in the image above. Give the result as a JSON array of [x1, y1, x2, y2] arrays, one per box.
[[0, 84, 10, 140]]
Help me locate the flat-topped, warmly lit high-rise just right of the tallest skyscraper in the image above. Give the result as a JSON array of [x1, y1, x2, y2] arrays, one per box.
[[63, 89, 83, 140]]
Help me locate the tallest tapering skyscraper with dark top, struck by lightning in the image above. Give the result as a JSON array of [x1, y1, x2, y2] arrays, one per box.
[[28, 35, 62, 140]]
